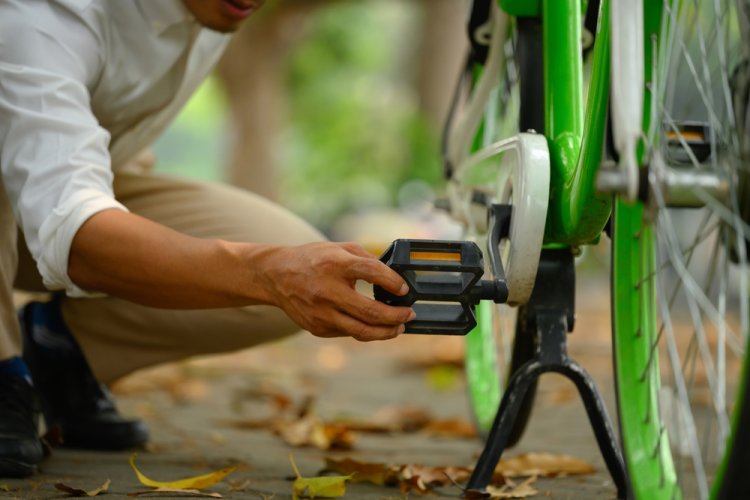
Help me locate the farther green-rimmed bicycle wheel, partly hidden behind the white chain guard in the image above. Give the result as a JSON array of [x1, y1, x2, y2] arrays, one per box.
[[464, 12, 544, 446]]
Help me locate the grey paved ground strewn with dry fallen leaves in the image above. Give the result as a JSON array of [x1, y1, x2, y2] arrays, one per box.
[[0, 248, 615, 499]]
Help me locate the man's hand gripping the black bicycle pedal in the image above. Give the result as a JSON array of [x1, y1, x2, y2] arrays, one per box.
[[264, 243, 415, 341]]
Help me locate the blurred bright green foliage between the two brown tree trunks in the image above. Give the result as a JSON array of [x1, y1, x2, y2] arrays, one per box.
[[281, 0, 440, 227]]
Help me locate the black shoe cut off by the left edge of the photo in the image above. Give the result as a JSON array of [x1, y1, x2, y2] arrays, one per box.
[[0, 375, 44, 477]]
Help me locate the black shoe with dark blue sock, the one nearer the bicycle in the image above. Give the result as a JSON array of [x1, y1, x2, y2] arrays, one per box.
[[19, 299, 148, 450]]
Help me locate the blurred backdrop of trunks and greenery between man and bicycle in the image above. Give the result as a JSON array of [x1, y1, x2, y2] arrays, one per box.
[[154, 0, 466, 237]]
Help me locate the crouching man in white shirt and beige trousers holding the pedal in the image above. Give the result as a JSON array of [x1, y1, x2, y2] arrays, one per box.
[[0, 0, 414, 477]]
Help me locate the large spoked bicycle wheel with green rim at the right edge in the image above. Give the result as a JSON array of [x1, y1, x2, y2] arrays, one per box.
[[612, 0, 750, 499]]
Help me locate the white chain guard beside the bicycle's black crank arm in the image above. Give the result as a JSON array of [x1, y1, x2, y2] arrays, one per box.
[[449, 133, 550, 305]]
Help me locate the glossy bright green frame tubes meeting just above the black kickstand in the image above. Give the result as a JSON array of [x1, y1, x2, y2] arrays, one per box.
[[543, 0, 612, 245]]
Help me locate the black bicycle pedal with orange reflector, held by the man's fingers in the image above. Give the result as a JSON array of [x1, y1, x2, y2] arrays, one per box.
[[374, 239, 492, 335]]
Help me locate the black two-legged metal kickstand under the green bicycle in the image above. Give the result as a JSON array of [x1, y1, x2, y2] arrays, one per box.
[[467, 249, 628, 498]]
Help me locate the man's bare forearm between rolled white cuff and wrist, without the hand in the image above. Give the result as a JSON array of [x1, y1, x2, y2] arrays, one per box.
[[68, 210, 273, 308]]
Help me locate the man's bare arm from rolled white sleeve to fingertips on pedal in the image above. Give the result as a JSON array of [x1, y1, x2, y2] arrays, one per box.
[[68, 209, 413, 340]]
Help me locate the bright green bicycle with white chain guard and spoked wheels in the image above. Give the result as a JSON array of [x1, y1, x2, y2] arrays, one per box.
[[378, 0, 750, 499]]
